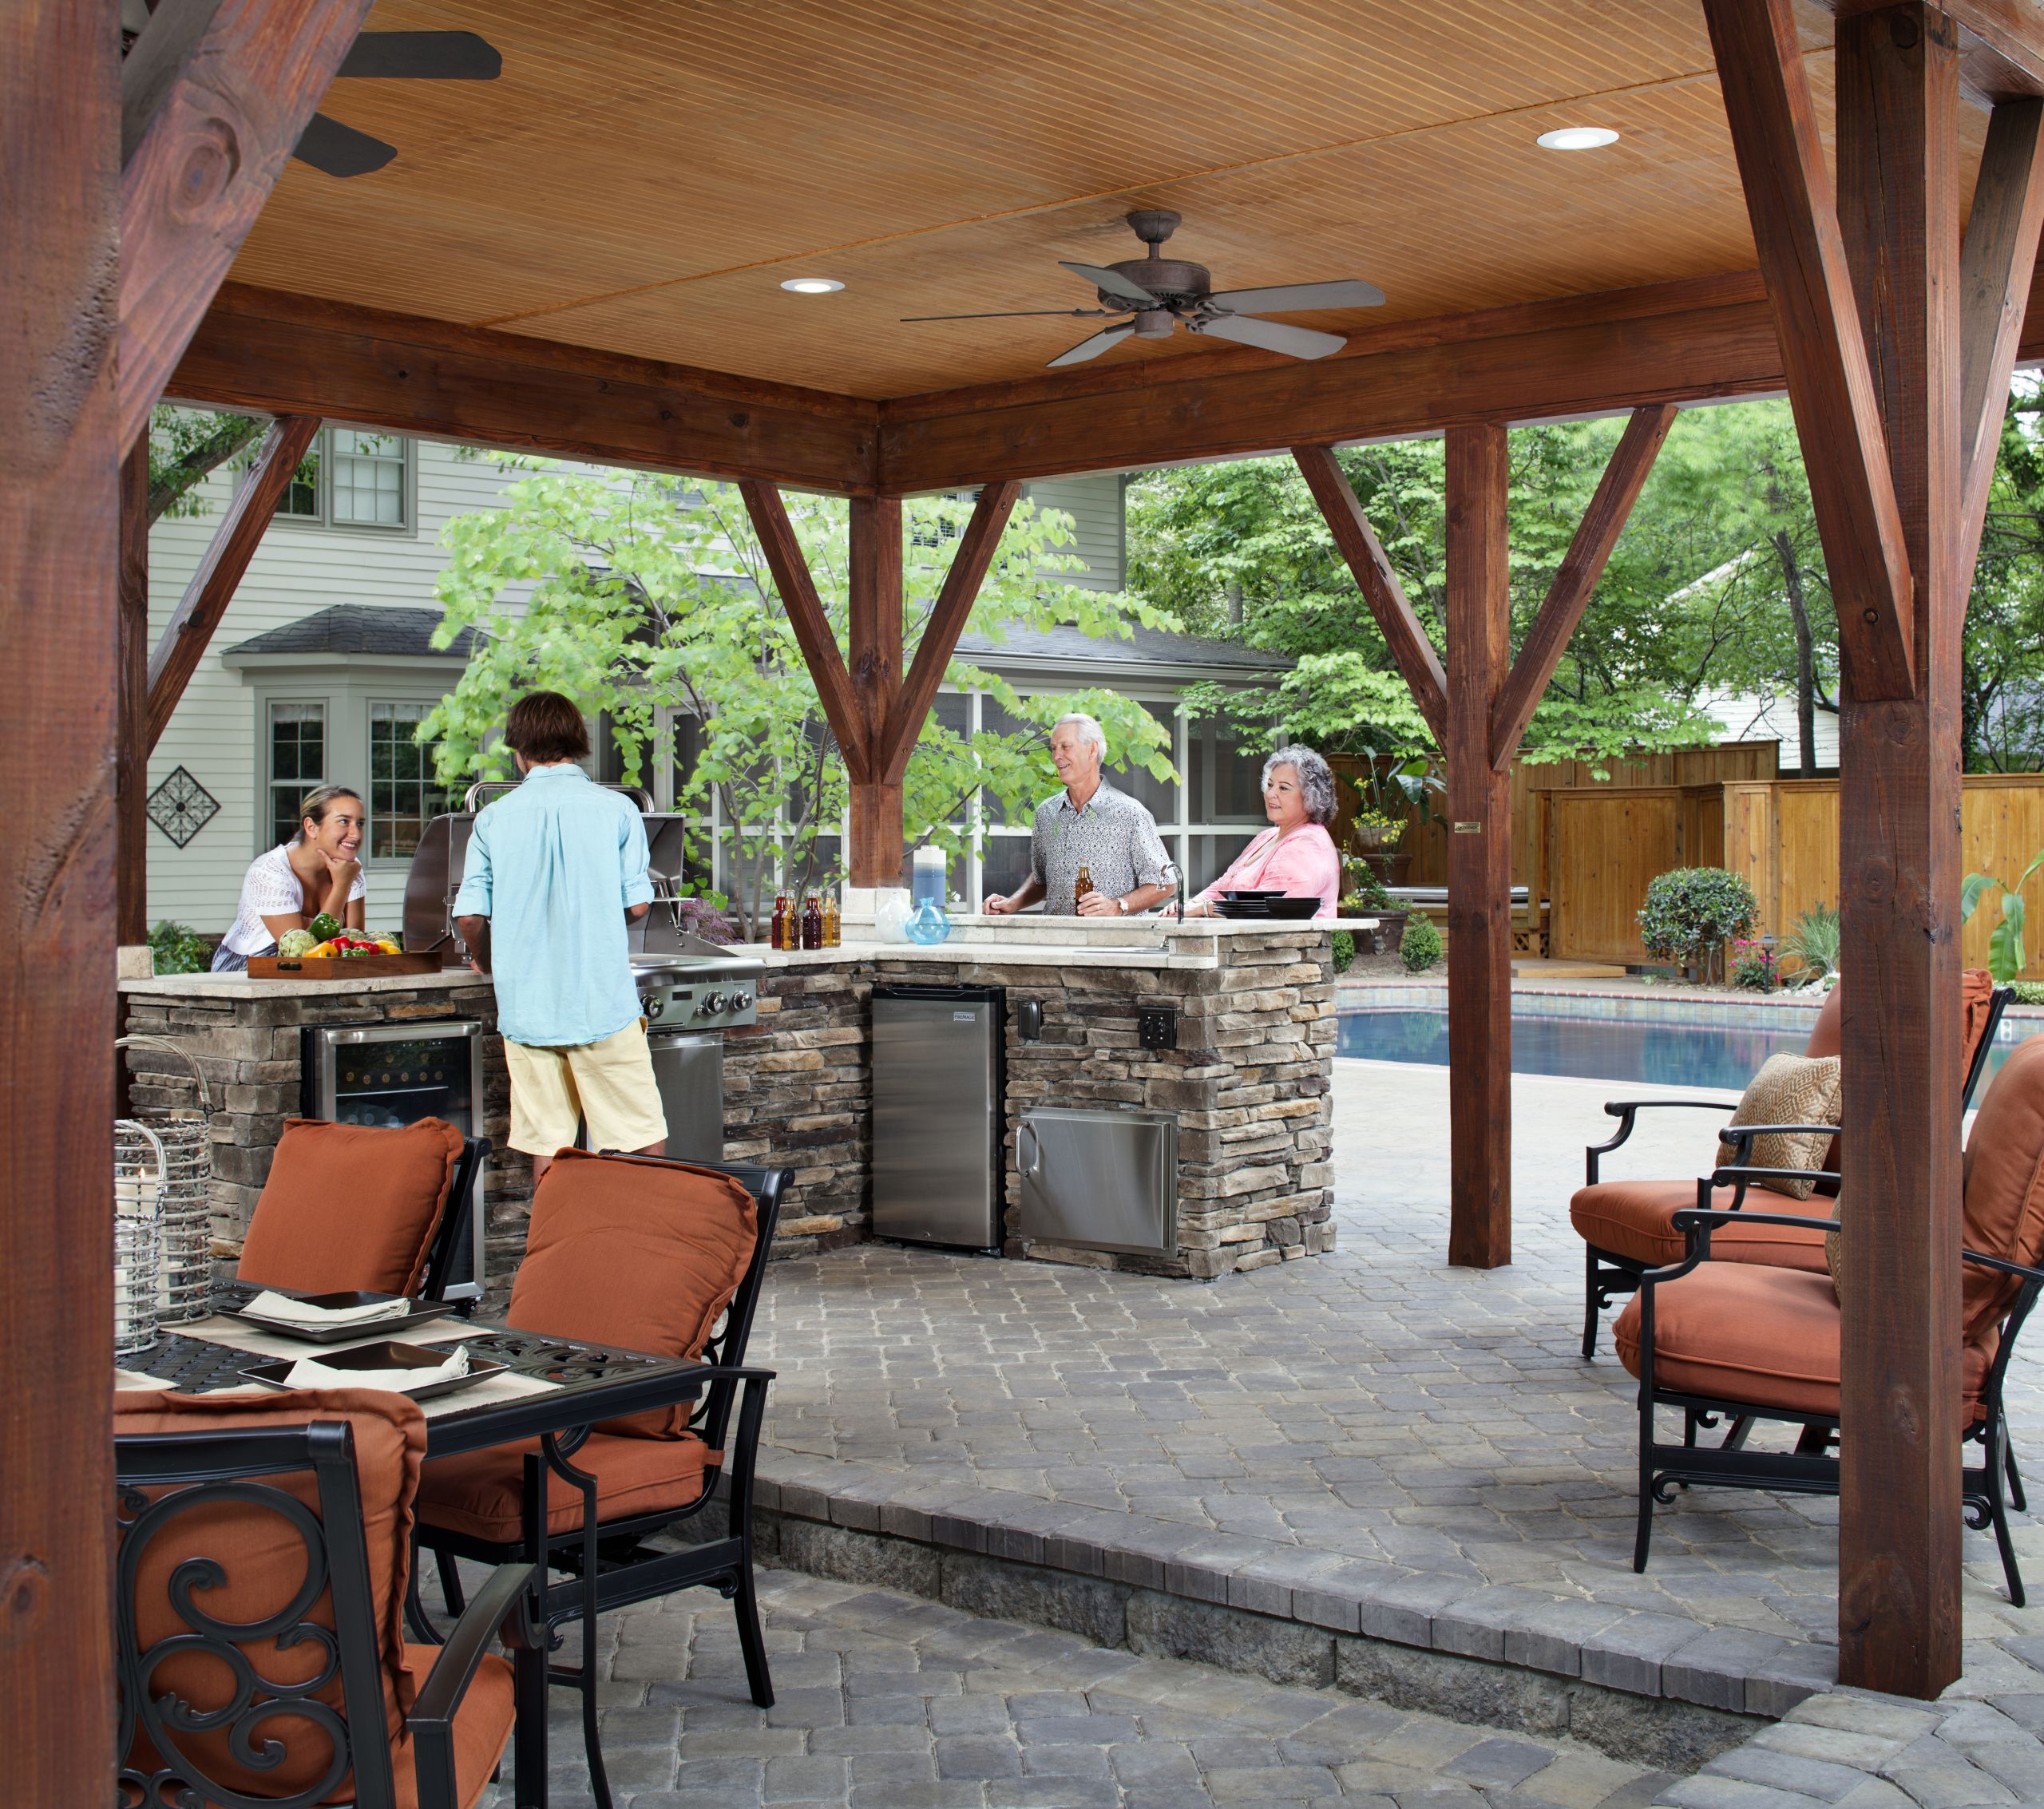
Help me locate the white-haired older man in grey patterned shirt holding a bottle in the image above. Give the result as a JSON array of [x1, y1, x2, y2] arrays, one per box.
[[985, 715, 1175, 918]]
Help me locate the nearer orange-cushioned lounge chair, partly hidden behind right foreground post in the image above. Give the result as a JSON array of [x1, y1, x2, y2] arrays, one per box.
[[1614, 1022, 2044, 1607]]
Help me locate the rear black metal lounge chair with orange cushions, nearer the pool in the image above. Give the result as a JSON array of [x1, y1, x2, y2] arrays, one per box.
[[1568, 969, 2015, 1360]]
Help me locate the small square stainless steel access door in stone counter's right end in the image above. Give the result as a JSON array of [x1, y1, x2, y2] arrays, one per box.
[[1016, 1106, 1178, 1255]]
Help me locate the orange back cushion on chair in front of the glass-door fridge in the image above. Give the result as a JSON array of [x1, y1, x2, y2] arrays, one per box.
[[237, 1118, 462, 1294]]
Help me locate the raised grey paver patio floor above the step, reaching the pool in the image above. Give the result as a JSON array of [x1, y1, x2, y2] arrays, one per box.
[[752, 1061, 2044, 1653]]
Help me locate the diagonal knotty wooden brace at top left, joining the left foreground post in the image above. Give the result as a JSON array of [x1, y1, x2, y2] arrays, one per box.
[[121, 0, 370, 448]]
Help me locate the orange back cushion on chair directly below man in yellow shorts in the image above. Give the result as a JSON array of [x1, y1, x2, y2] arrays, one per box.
[[505, 1149, 759, 1439]]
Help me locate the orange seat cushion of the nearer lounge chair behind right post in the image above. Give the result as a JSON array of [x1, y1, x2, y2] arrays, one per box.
[[1614, 1267, 1995, 1423]]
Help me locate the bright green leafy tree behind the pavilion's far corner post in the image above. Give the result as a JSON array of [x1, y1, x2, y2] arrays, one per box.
[[419, 456, 1175, 932]]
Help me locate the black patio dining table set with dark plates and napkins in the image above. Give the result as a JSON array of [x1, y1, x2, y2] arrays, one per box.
[[114, 1314, 707, 1809]]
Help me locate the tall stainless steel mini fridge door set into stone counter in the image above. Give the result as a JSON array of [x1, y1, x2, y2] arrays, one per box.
[[873, 988, 1006, 1249]]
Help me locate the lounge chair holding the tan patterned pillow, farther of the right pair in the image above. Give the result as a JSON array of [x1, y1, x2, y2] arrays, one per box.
[[1570, 973, 2015, 1360]]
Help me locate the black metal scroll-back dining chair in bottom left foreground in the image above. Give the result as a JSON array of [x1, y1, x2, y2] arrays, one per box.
[[114, 1419, 537, 1809]]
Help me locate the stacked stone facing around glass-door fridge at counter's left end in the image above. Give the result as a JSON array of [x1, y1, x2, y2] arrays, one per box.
[[121, 984, 532, 1300]]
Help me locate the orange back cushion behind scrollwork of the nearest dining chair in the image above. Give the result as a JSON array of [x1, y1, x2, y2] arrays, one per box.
[[114, 1388, 425, 1797]]
